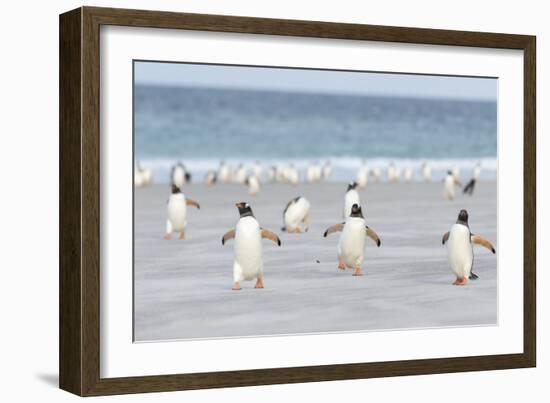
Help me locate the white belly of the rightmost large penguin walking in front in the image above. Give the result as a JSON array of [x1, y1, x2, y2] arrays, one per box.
[[447, 224, 474, 279]]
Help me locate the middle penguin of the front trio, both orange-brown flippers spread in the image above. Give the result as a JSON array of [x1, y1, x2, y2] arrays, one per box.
[[323, 204, 381, 276]]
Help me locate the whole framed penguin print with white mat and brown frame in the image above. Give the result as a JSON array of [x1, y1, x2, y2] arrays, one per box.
[[60, 7, 536, 396]]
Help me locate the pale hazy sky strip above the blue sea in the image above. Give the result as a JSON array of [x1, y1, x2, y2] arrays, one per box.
[[135, 62, 497, 101]]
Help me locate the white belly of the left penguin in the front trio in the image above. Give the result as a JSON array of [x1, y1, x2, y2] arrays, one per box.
[[233, 217, 263, 281]]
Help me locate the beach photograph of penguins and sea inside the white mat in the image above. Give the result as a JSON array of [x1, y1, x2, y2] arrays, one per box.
[[131, 60, 498, 342]]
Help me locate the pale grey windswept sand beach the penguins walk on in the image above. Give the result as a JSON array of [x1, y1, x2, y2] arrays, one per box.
[[134, 182, 498, 341]]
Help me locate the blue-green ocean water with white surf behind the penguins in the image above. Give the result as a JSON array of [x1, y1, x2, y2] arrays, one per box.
[[134, 85, 497, 182]]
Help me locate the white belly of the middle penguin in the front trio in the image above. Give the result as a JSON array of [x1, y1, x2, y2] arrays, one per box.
[[338, 217, 366, 268]]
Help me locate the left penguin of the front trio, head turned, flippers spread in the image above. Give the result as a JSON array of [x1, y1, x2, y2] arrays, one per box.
[[222, 202, 281, 290]]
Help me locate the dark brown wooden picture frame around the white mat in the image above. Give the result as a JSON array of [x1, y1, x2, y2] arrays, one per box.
[[59, 7, 536, 396]]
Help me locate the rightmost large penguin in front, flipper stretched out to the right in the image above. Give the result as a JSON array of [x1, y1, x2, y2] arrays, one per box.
[[442, 210, 495, 285]]
